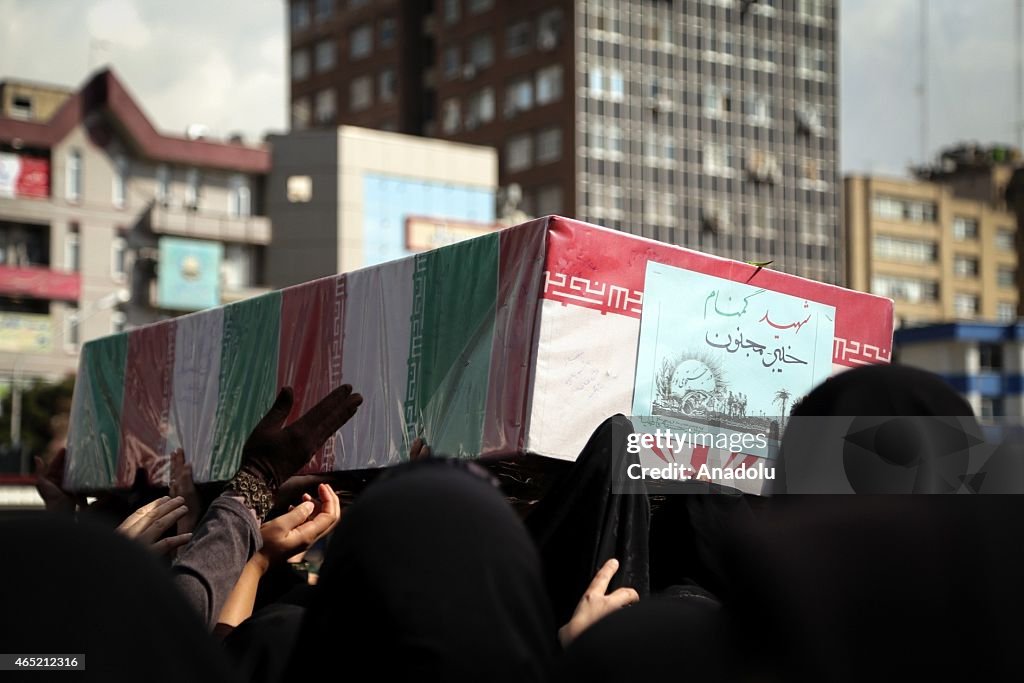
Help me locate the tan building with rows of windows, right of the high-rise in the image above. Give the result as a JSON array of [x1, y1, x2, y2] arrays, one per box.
[[844, 146, 1020, 326]]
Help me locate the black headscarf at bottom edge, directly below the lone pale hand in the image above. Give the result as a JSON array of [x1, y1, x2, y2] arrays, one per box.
[[554, 593, 730, 683]]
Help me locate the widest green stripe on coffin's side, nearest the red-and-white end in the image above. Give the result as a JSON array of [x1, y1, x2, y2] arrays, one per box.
[[406, 232, 500, 456]]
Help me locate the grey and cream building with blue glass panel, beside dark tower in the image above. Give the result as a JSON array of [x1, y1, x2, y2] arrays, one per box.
[[266, 126, 498, 287]]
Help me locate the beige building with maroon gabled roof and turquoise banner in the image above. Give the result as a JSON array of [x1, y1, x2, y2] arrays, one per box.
[[0, 71, 270, 384]]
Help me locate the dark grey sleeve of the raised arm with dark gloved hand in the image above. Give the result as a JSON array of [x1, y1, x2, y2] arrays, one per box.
[[171, 496, 262, 628]]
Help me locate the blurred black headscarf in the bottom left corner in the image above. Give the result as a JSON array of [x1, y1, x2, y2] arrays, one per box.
[[0, 513, 237, 683]]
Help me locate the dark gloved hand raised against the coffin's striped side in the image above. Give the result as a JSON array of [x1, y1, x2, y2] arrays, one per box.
[[240, 384, 362, 490]]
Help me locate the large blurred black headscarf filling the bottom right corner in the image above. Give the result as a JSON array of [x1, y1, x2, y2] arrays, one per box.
[[732, 496, 1024, 682]]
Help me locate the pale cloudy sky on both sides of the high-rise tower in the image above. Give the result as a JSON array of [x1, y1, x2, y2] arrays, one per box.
[[0, 0, 1017, 178]]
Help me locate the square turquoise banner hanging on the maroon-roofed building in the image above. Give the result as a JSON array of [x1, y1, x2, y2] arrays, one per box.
[[157, 238, 224, 310]]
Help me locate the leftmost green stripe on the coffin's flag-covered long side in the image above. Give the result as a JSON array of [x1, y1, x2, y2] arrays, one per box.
[[67, 332, 128, 490]]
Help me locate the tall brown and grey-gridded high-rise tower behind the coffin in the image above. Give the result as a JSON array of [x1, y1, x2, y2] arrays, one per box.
[[289, 0, 845, 283]]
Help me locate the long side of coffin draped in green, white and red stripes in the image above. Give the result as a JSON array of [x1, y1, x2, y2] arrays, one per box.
[[67, 225, 545, 489]]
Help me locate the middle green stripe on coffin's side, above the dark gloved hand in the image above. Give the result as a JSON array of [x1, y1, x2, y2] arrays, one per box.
[[205, 292, 281, 481]]
